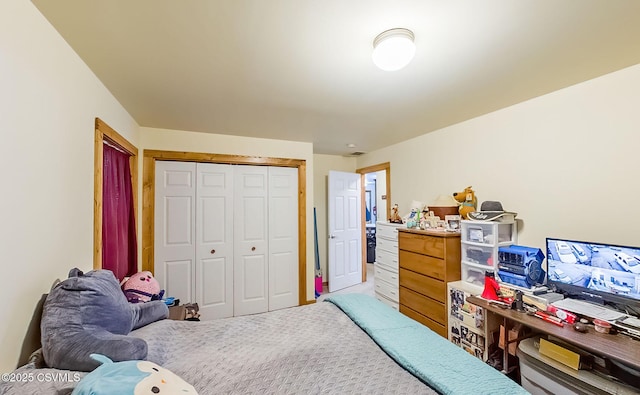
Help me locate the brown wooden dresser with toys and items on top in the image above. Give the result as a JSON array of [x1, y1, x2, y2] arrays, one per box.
[[398, 228, 460, 338]]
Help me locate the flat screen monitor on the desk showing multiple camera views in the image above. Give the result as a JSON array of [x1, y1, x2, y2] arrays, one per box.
[[547, 238, 640, 316]]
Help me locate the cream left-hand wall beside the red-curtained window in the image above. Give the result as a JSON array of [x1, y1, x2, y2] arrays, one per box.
[[0, 0, 138, 372]]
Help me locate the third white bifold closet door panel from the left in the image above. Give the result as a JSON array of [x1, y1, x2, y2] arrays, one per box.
[[233, 165, 269, 316]]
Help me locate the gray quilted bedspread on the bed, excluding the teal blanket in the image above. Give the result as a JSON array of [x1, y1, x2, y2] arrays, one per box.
[[0, 303, 435, 395]]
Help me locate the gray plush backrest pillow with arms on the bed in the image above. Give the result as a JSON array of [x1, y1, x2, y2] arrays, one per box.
[[40, 268, 169, 372]]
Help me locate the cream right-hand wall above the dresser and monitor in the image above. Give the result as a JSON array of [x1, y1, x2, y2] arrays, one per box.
[[358, 65, 640, 250]]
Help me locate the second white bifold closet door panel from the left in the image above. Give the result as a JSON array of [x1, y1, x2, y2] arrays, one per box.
[[195, 163, 234, 320]]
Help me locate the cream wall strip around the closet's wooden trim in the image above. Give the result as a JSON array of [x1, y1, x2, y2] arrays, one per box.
[[138, 128, 314, 300]]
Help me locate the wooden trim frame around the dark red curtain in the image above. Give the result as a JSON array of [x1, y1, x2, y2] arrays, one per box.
[[93, 118, 138, 269]]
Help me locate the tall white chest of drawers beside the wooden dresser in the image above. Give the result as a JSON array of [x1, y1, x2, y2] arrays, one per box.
[[374, 222, 404, 310]]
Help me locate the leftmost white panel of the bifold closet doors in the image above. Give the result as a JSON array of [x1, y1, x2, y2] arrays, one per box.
[[154, 161, 196, 303]]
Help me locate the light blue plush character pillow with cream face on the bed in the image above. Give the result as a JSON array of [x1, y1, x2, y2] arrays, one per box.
[[72, 354, 197, 395]]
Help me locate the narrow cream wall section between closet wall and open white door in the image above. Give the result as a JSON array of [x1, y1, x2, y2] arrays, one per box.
[[311, 155, 356, 282]]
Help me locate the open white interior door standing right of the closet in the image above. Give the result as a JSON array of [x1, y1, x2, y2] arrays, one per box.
[[328, 171, 362, 292]]
